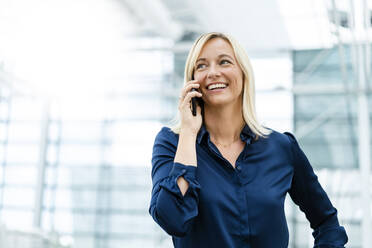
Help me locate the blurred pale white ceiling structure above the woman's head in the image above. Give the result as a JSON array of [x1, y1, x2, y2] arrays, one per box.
[[118, 0, 348, 52]]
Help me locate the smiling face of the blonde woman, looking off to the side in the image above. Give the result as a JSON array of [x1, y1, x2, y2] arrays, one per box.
[[194, 38, 243, 106]]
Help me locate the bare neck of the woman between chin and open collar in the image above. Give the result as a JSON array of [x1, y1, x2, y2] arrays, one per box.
[[204, 100, 245, 146]]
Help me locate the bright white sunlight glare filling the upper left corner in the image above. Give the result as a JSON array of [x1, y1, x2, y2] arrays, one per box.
[[0, 0, 132, 97]]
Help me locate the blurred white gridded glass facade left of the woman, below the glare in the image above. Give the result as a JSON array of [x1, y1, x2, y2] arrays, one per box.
[[0, 35, 176, 248]]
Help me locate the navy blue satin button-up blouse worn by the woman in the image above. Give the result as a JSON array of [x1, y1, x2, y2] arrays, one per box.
[[149, 125, 348, 248]]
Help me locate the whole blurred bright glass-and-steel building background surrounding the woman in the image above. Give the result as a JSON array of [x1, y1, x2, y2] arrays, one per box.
[[0, 0, 372, 248]]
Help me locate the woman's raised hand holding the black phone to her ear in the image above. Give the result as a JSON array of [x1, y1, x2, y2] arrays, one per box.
[[178, 80, 202, 136]]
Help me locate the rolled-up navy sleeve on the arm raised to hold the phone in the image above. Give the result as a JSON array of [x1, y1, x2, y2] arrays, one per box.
[[149, 128, 200, 237]]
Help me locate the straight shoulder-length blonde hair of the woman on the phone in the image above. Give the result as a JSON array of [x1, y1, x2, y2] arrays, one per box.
[[170, 32, 272, 138]]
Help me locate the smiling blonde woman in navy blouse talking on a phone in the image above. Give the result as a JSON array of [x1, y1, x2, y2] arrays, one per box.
[[149, 33, 348, 248]]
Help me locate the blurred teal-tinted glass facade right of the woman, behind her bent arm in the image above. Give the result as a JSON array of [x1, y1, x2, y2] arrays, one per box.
[[292, 45, 372, 247]]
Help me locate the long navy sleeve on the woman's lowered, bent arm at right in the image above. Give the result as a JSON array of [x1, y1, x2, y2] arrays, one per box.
[[284, 132, 348, 248]]
